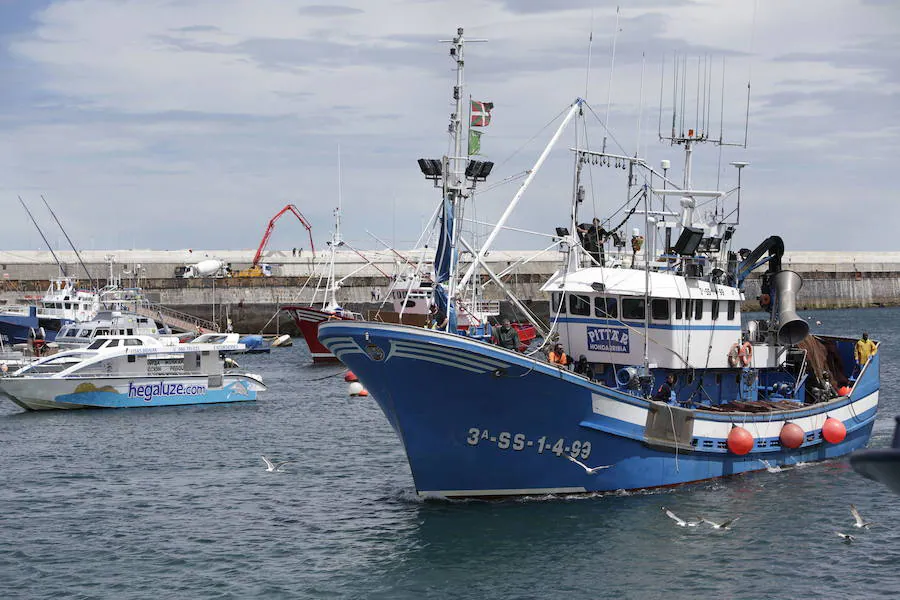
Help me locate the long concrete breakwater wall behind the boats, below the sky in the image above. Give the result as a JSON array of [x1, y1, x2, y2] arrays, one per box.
[[0, 250, 900, 333]]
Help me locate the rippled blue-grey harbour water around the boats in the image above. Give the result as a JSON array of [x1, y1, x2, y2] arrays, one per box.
[[0, 309, 900, 600]]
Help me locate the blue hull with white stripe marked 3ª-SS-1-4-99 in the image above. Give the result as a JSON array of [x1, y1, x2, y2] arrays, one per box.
[[319, 322, 878, 497]]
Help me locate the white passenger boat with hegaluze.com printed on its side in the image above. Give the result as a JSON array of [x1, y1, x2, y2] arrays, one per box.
[[0, 336, 266, 410]]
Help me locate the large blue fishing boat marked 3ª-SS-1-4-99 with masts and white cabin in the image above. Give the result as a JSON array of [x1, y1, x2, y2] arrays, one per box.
[[319, 29, 879, 497]]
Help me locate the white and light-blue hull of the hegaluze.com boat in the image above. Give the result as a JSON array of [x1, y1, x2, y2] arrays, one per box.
[[0, 375, 266, 410]]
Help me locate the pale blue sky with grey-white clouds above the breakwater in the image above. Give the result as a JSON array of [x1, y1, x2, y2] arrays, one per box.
[[0, 0, 900, 251]]
